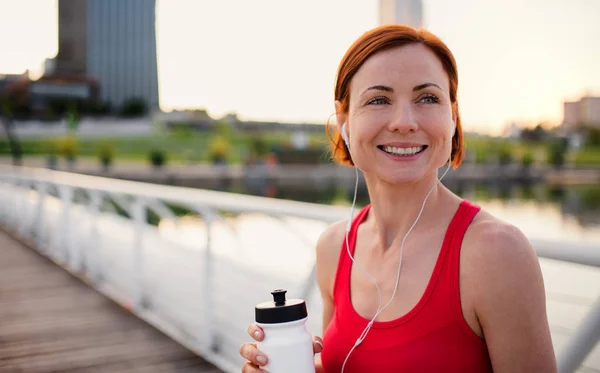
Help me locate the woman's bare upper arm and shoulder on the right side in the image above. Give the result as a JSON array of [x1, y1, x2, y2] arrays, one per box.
[[465, 221, 557, 373]]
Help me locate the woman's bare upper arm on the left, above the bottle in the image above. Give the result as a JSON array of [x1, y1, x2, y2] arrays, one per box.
[[316, 221, 346, 333]]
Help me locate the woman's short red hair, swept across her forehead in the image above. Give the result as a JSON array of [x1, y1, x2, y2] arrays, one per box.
[[327, 25, 465, 168]]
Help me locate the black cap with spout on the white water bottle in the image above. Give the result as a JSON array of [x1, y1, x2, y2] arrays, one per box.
[[255, 289, 308, 324]]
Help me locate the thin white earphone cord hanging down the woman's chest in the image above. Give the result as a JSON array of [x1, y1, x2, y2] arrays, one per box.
[[341, 160, 452, 373]]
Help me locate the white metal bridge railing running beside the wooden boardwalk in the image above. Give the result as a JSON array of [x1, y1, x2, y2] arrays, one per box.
[[0, 166, 600, 373]]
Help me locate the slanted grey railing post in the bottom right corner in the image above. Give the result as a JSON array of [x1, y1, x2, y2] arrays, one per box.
[[558, 298, 600, 373]]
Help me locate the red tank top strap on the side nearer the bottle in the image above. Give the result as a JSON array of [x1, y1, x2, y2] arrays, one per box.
[[333, 204, 371, 303]]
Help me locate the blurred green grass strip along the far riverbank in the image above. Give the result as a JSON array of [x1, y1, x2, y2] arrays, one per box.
[[0, 131, 600, 167]]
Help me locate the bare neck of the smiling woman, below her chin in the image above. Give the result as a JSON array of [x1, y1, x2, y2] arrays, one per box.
[[365, 169, 448, 251]]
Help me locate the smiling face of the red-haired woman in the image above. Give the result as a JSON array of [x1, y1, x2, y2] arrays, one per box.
[[336, 44, 455, 184]]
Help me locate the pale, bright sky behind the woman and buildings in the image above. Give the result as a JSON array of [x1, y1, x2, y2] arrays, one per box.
[[0, 0, 600, 134]]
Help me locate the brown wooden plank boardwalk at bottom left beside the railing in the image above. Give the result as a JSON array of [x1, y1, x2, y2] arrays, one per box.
[[0, 230, 221, 373]]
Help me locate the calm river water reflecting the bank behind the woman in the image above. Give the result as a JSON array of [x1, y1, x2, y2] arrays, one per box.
[[213, 183, 600, 243]]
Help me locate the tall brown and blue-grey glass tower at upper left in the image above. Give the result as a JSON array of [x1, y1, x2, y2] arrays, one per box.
[[54, 0, 159, 108]]
